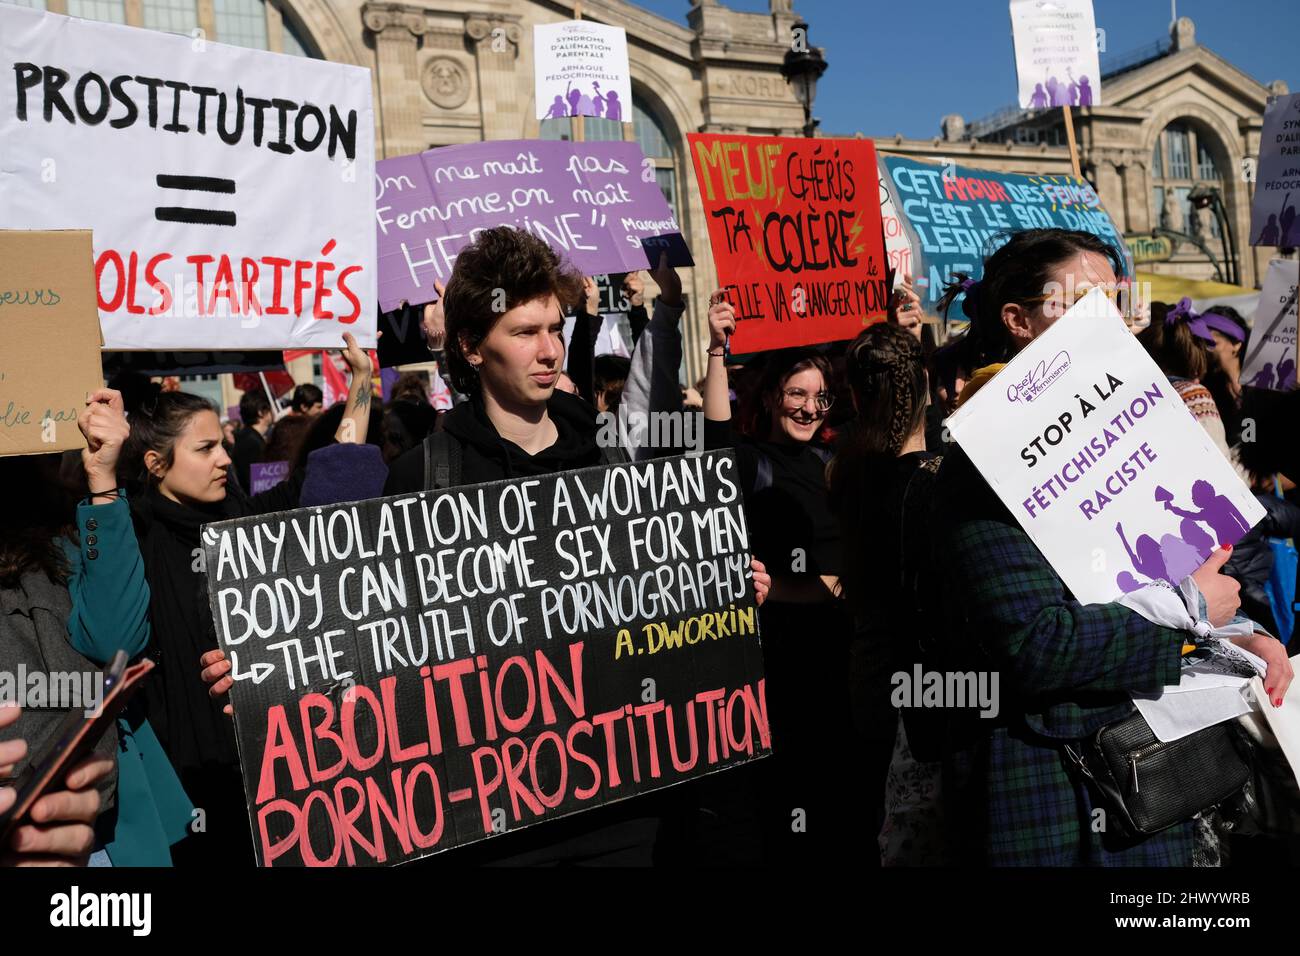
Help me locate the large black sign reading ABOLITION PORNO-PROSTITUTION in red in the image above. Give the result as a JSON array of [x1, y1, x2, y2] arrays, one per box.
[[204, 451, 771, 866]]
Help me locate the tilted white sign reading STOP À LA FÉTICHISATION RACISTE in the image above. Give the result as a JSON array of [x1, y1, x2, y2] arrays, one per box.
[[945, 289, 1264, 604]]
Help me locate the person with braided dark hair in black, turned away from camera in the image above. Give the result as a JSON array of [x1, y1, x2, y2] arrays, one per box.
[[827, 323, 943, 866]]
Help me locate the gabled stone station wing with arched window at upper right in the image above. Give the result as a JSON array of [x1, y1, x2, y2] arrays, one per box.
[[875, 17, 1287, 287]]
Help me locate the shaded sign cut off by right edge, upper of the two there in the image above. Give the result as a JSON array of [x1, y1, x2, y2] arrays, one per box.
[[1251, 92, 1300, 246]]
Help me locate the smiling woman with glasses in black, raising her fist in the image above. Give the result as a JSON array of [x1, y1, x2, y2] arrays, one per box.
[[686, 294, 852, 861]]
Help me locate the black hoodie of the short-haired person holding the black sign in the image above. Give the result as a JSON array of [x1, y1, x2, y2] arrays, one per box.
[[384, 392, 601, 494]]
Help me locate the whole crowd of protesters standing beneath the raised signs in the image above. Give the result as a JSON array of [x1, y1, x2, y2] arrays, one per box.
[[0, 228, 1300, 868]]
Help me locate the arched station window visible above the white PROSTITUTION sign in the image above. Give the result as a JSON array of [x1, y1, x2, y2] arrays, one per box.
[[50, 0, 320, 59]]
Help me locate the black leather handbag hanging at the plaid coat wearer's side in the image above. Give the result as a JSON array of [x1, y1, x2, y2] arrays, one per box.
[[1065, 711, 1251, 838]]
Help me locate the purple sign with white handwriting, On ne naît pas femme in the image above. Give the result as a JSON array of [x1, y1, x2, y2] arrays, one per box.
[[374, 139, 694, 311]]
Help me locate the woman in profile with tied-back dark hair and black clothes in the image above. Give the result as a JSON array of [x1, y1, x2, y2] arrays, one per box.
[[130, 334, 382, 865]]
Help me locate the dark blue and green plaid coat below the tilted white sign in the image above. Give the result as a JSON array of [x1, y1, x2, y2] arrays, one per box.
[[935, 450, 1193, 866]]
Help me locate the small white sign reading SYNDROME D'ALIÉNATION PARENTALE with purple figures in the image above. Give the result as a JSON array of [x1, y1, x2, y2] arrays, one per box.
[[533, 20, 632, 122]]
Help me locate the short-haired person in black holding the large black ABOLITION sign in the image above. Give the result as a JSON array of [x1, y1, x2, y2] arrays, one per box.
[[374, 228, 767, 864]]
